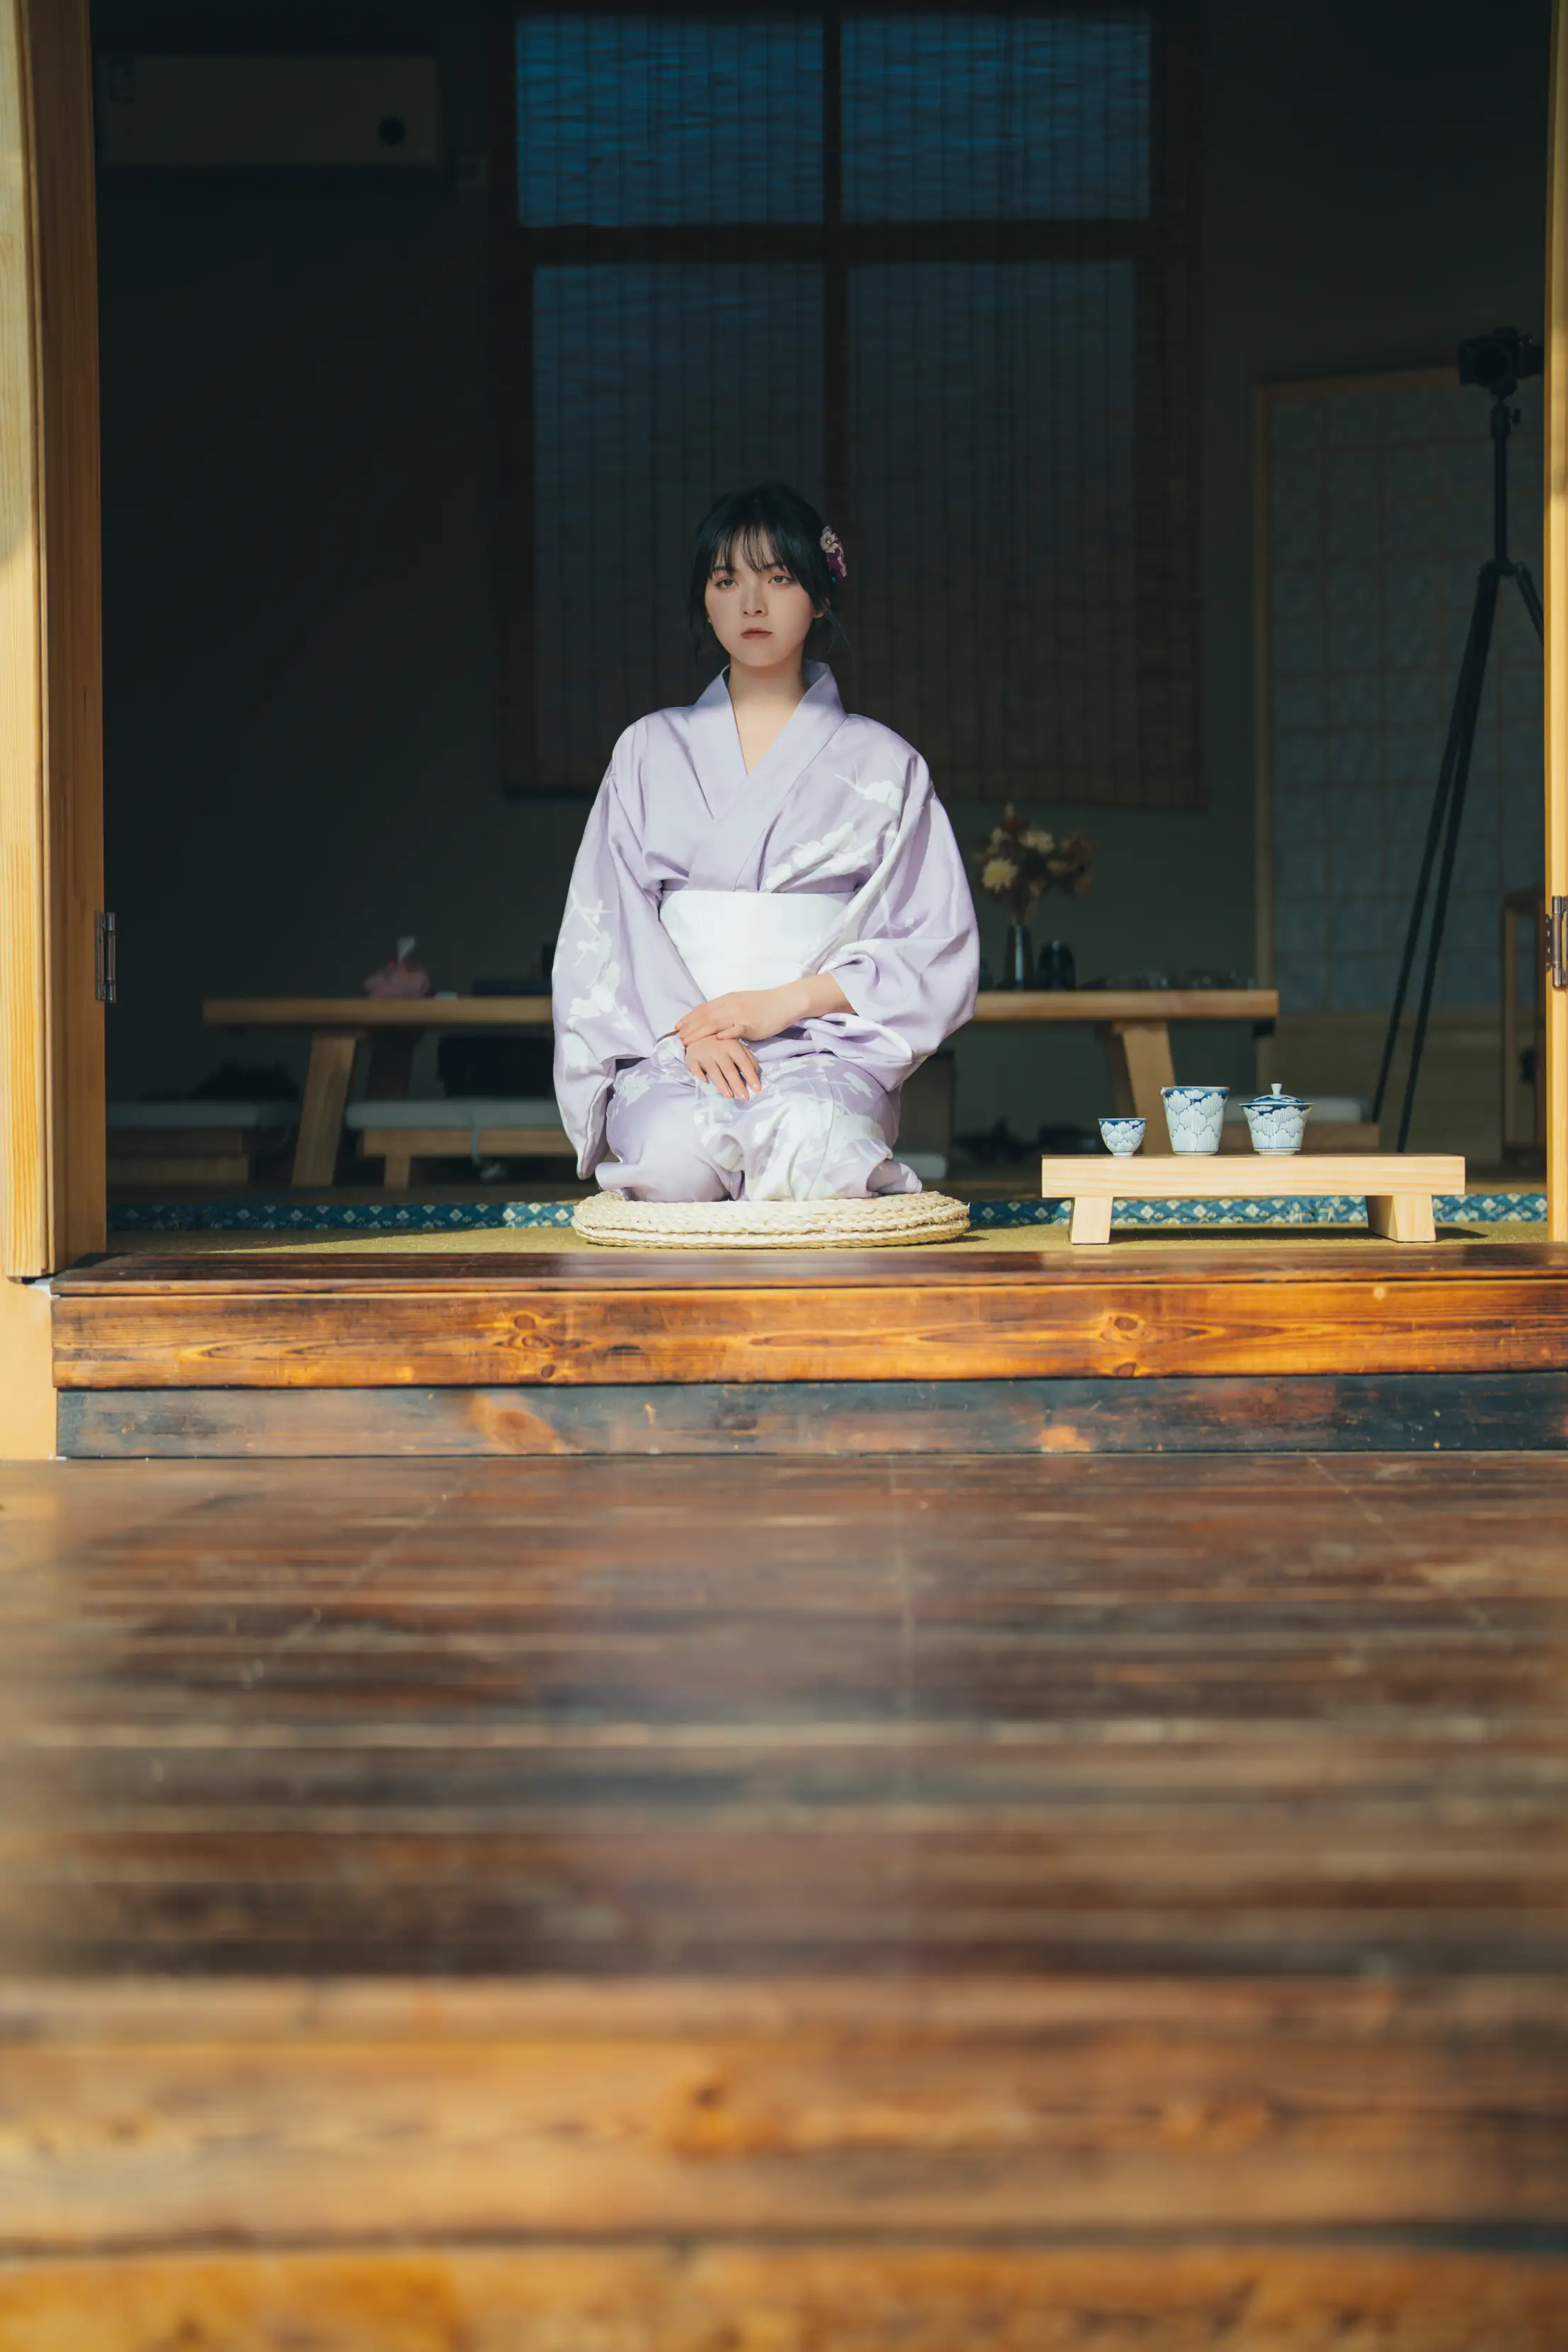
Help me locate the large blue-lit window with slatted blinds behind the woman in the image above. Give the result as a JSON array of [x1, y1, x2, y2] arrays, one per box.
[[496, 0, 1197, 807]]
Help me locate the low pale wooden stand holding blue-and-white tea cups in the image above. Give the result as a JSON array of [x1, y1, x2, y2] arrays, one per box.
[[1039, 1152, 1465, 1242]]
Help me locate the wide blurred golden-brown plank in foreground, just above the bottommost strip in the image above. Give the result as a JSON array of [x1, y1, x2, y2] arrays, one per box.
[[0, 1987, 1568, 2256]]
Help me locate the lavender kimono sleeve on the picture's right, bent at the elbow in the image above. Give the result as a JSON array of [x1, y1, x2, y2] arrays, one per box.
[[811, 753, 980, 1086]]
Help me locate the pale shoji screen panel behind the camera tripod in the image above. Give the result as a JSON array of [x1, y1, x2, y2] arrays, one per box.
[[1258, 367, 1542, 1013]]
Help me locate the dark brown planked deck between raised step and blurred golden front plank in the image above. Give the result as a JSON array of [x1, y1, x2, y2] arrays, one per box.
[[0, 1456, 1568, 1978]]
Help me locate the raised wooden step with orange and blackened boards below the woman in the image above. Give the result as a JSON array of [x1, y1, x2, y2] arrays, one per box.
[[54, 1228, 1568, 1456]]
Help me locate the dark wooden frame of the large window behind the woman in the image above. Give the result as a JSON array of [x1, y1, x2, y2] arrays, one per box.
[[489, 0, 1206, 809]]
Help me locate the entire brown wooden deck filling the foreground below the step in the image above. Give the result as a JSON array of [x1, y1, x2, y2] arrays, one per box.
[[0, 1456, 1568, 2352]]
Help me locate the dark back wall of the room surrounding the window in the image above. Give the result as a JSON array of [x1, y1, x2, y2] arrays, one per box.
[[96, 0, 1549, 1131]]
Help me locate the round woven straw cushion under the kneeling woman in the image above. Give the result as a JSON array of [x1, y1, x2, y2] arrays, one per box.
[[572, 1193, 969, 1249]]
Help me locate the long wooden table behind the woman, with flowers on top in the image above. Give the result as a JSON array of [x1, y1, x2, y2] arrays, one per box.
[[202, 988, 1279, 1186]]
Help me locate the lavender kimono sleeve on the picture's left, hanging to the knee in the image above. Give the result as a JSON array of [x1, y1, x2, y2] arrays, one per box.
[[552, 727, 700, 1176]]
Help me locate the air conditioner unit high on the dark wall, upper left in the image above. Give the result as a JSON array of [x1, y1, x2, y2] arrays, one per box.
[[96, 54, 442, 171]]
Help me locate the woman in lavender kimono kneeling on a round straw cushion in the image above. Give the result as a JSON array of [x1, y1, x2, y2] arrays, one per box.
[[555, 482, 978, 1200]]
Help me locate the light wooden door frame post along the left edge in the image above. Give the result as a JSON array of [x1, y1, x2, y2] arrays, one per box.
[[0, 0, 106, 1280]]
